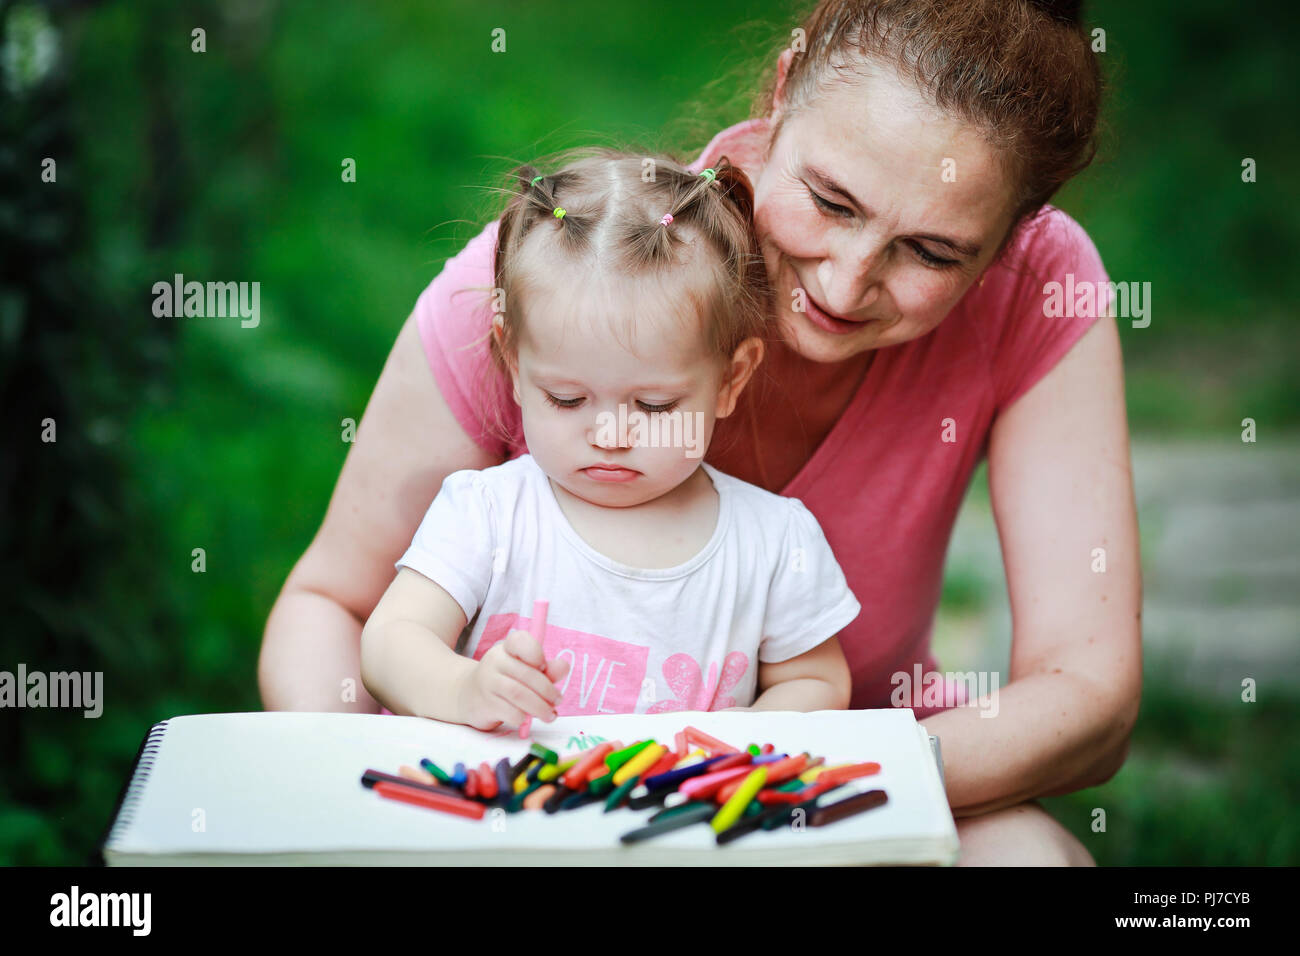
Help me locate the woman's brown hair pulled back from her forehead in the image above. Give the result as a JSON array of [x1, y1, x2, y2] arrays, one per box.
[[755, 0, 1102, 246]]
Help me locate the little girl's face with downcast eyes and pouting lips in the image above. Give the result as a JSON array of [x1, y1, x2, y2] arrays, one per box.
[[496, 264, 762, 507]]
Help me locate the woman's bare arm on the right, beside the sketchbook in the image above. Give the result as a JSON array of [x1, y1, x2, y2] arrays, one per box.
[[922, 317, 1141, 817]]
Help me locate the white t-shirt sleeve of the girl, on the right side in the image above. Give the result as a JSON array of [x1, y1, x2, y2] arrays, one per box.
[[758, 498, 862, 663]]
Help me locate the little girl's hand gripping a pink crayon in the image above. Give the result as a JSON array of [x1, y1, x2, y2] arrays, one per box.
[[460, 628, 571, 731]]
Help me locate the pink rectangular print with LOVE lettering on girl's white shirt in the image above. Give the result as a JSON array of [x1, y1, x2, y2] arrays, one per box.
[[475, 614, 650, 717]]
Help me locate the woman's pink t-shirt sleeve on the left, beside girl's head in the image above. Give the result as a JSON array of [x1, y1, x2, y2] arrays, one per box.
[[415, 221, 523, 459]]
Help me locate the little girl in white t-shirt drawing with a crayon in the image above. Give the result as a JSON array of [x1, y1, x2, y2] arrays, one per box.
[[361, 148, 859, 730]]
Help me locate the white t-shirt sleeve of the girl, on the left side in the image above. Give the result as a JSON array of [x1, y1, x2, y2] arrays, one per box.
[[394, 471, 497, 620]]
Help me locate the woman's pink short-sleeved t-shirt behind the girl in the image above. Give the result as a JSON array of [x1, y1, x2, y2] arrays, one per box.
[[415, 120, 1108, 717]]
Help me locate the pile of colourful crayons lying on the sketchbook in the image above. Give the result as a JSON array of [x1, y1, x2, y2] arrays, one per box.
[[361, 727, 888, 845]]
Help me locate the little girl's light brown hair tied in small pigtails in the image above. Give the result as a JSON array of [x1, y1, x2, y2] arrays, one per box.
[[490, 147, 770, 372]]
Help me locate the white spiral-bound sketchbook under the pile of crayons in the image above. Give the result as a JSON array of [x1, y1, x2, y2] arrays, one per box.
[[100, 709, 958, 866]]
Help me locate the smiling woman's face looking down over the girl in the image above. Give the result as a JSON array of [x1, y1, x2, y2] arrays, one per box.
[[754, 51, 1011, 362]]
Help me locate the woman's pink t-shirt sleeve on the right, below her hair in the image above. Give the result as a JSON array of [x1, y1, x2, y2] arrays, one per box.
[[991, 207, 1109, 411]]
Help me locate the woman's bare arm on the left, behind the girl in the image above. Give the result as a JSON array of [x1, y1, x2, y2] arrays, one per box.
[[257, 315, 499, 713]]
